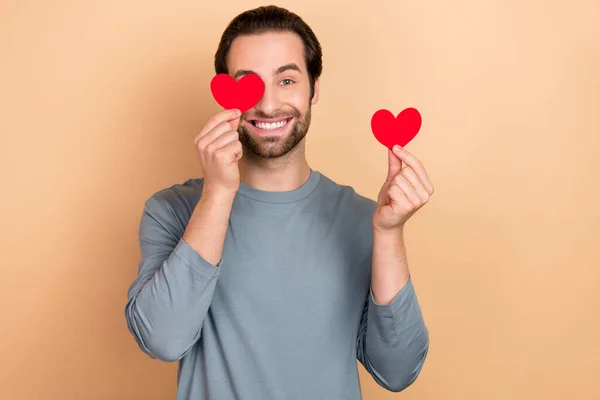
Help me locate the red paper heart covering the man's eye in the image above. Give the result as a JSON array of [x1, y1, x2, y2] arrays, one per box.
[[210, 74, 265, 113]]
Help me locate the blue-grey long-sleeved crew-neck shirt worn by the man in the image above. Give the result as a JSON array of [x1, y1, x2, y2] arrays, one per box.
[[125, 170, 429, 400]]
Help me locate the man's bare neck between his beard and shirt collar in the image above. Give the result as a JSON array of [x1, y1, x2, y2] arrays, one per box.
[[238, 140, 310, 192]]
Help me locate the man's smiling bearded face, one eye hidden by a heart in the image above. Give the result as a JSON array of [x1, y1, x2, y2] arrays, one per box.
[[227, 32, 319, 158]]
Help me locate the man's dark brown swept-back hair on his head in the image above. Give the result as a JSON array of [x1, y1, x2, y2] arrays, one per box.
[[215, 5, 323, 99]]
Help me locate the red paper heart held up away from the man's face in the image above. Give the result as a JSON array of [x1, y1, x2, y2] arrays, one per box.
[[371, 108, 421, 150]]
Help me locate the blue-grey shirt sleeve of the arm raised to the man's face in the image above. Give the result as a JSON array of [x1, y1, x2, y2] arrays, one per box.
[[125, 194, 222, 362]]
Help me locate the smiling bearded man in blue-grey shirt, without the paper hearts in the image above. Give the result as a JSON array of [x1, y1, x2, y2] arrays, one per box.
[[125, 6, 433, 400]]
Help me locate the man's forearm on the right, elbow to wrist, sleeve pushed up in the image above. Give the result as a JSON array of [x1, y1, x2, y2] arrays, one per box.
[[357, 227, 429, 392]]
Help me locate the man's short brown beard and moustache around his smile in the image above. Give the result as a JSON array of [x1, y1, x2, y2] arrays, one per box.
[[238, 104, 312, 158]]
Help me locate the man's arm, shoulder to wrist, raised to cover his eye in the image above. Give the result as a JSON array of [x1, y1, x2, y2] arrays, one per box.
[[125, 187, 235, 362]]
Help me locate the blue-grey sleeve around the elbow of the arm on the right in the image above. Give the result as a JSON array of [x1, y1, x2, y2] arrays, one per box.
[[357, 278, 429, 392]]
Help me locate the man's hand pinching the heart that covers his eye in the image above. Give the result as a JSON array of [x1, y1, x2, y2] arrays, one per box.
[[194, 109, 243, 192]]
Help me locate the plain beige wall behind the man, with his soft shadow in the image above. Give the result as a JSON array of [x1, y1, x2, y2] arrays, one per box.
[[0, 0, 600, 400]]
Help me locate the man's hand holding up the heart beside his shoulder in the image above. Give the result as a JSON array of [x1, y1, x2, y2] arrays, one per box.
[[373, 146, 433, 232]]
